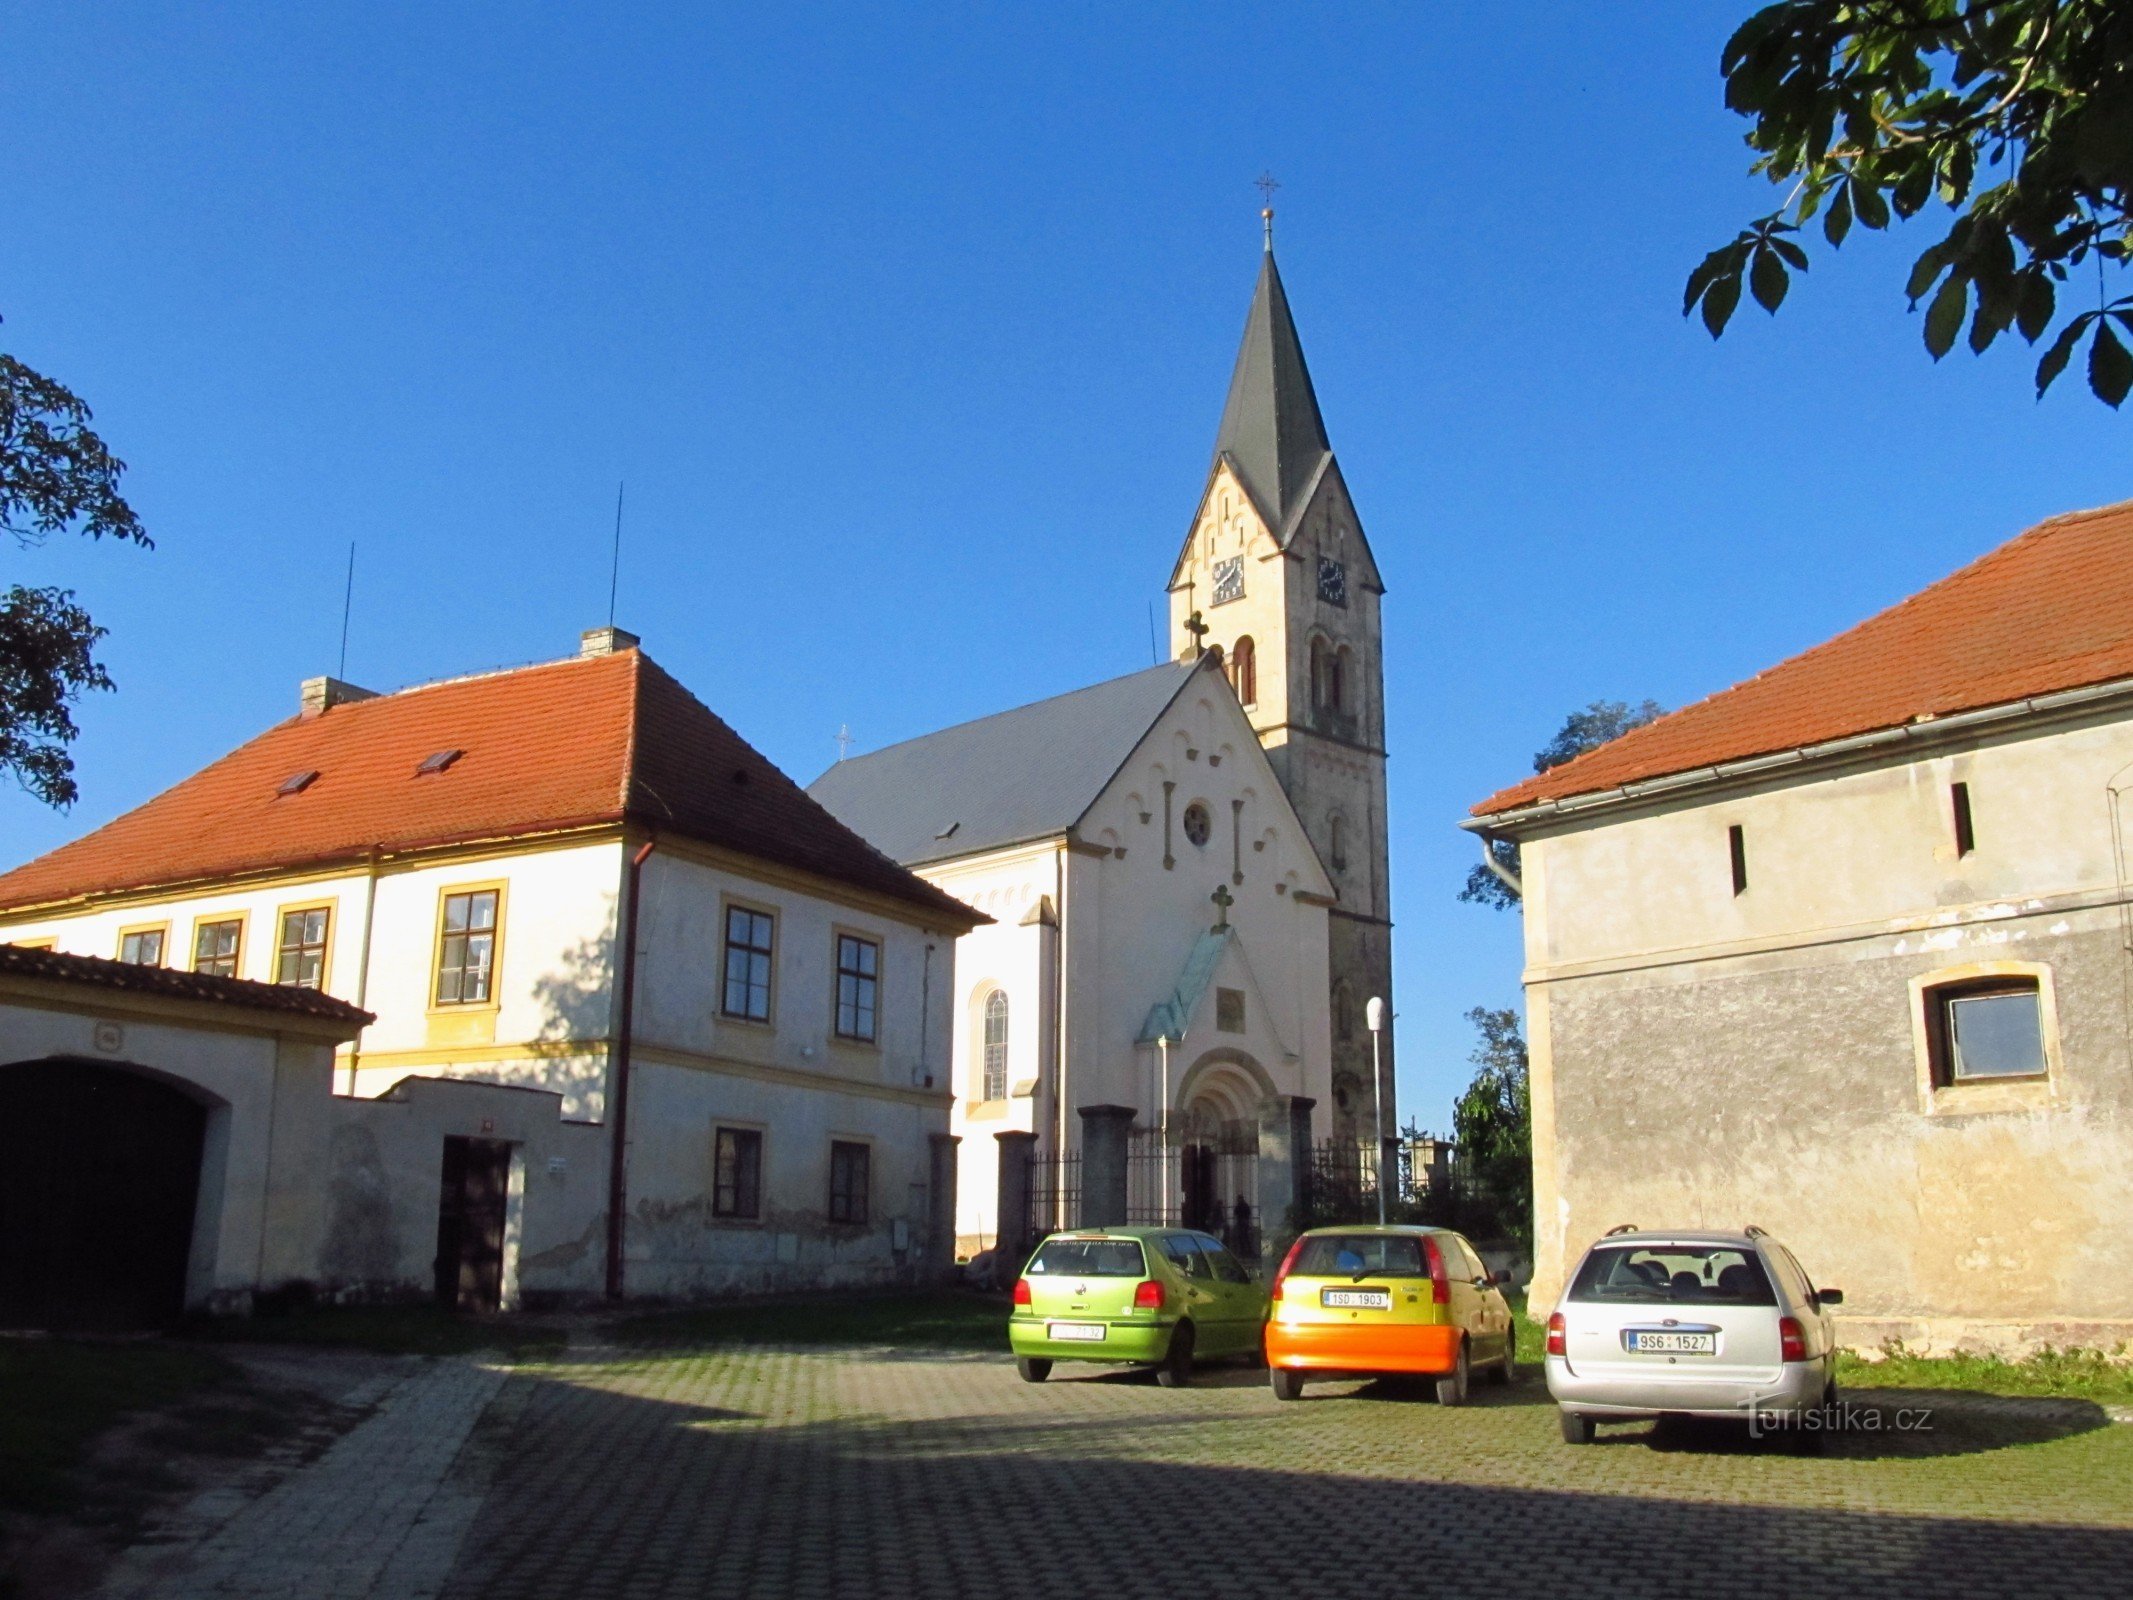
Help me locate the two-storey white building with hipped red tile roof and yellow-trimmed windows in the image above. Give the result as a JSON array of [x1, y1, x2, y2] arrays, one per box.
[[0, 629, 985, 1301]]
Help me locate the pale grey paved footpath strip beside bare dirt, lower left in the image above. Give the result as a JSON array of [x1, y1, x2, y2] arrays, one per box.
[[98, 1361, 511, 1600]]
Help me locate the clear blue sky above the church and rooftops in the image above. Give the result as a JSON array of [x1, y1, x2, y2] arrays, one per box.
[[0, 0, 2133, 1126]]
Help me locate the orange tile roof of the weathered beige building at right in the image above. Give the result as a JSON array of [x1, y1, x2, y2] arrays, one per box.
[[1474, 501, 2133, 817]]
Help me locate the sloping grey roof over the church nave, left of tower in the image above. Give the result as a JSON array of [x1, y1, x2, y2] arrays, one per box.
[[808, 661, 1194, 866]]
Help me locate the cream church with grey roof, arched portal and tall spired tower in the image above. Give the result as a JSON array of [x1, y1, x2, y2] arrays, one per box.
[[808, 226, 1397, 1257]]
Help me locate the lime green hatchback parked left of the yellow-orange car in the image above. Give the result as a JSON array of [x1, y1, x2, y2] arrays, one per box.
[[1007, 1227, 1267, 1389]]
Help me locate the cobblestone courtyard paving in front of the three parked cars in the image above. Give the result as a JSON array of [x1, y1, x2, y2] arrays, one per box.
[[432, 1350, 2133, 1600]]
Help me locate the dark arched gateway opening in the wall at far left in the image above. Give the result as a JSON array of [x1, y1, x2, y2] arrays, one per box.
[[0, 1060, 207, 1331]]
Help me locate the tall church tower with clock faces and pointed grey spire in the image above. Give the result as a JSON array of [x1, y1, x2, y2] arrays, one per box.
[[1169, 228, 1399, 1139]]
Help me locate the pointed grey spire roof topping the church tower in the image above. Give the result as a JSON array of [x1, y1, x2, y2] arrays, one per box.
[[1214, 250, 1333, 540]]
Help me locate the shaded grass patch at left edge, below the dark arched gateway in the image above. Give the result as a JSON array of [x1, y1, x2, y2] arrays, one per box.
[[0, 1340, 232, 1513]]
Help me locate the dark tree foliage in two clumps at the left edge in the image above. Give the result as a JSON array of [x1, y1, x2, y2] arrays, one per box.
[[0, 332, 151, 806]]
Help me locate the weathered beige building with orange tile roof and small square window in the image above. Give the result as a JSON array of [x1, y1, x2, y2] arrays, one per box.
[[1468, 506, 2133, 1348]]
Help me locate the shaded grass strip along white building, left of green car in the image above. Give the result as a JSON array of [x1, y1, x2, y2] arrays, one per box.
[[612, 1293, 1007, 1353]]
